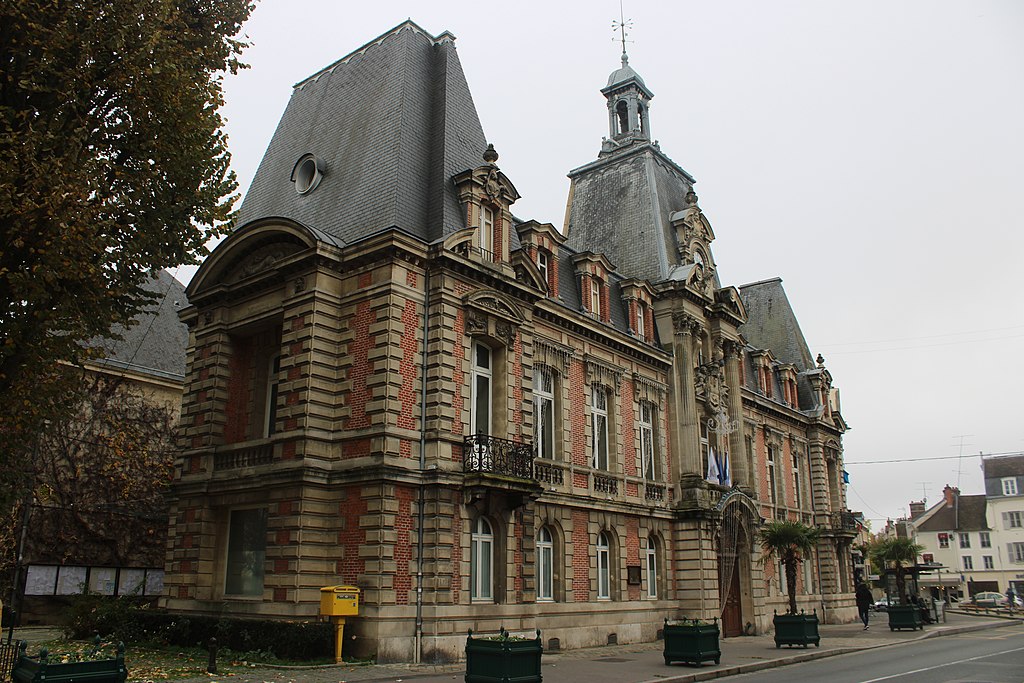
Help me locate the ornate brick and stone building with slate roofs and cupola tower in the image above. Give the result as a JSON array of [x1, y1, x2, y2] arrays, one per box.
[[164, 22, 856, 661]]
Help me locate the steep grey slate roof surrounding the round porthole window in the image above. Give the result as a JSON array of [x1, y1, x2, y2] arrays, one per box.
[[238, 20, 486, 244]]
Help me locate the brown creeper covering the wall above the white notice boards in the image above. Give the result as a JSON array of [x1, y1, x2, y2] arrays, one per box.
[[0, 369, 177, 602]]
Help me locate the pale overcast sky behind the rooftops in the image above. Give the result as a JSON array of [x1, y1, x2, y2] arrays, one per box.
[[190, 0, 1024, 529]]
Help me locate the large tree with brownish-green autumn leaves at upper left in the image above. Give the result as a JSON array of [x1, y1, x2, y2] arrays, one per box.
[[0, 0, 252, 499]]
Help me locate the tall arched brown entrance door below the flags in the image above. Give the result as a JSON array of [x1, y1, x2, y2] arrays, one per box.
[[718, 494, 755, 638]]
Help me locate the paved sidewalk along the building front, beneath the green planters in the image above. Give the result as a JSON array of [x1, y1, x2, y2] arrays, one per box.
[[165, 612, 1022, 683]]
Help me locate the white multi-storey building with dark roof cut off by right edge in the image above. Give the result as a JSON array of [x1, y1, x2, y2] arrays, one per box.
[[981, 454, 1024, 596]]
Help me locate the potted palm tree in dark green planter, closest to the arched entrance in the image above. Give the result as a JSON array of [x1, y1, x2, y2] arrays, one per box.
[[761, 520, 821, 647]]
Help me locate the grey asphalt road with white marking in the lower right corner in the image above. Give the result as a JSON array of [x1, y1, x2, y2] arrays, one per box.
[[722, 626, 1024, 683]]
